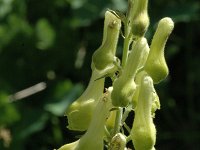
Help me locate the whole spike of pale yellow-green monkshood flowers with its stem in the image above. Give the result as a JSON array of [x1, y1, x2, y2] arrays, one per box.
[[56, 0, 174, 150]]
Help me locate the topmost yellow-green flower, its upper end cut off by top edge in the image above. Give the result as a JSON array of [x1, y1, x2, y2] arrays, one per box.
[[131, 0, 149, 37]]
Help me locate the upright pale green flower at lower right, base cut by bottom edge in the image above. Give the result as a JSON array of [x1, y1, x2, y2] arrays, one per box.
[[131, 76, 156, 150]]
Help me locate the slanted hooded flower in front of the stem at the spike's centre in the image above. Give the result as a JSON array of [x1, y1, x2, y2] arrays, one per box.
[[111, 38, 149, 107]]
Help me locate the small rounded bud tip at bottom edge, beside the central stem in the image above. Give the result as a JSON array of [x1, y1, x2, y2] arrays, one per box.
[[110, 133, 126, 150]]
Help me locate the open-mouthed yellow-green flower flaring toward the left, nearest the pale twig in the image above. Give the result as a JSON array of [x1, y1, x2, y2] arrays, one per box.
[[66, 69, 105, 131]]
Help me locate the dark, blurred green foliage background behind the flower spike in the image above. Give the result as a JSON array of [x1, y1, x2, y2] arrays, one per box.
[[0, 0, 200, 150]]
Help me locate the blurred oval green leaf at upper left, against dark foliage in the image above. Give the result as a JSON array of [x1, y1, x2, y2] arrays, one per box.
[[36, 19, 55, 50]]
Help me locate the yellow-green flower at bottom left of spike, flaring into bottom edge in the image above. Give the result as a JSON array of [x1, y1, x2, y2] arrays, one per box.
[[59, 87, 112, 150]]
